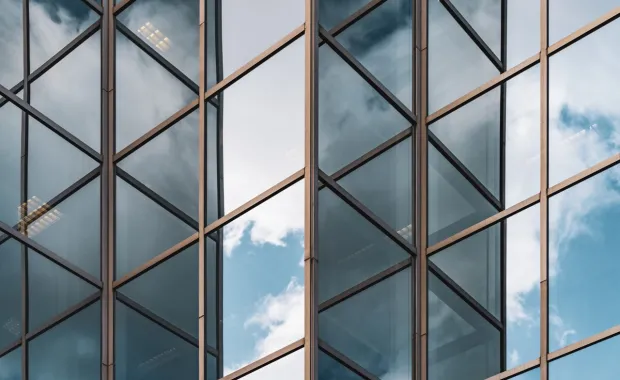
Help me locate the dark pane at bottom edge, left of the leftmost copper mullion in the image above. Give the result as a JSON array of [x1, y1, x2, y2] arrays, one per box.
[[28, 302, 101, 380]]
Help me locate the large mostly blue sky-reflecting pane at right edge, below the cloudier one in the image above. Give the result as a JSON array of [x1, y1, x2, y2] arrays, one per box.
[[549, 166, 620, 351]]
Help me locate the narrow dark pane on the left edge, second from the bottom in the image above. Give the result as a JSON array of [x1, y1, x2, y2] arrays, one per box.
[[0, 240, 22, 348]]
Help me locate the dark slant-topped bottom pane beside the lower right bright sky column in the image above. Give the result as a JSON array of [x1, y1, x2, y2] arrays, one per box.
[[428, 273, 501, 380]]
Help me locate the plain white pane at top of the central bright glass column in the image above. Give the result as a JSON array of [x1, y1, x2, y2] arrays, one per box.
[[217, 0, 305, 80]]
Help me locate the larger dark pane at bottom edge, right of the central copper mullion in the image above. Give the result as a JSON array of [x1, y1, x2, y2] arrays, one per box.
[[319, 268, 412, 379]]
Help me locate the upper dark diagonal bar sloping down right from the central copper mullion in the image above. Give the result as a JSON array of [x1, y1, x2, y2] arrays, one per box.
[[319, 27, 416, 124]]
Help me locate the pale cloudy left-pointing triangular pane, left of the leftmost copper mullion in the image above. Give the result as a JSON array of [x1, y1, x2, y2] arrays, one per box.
[[30, 32, 101, 151]]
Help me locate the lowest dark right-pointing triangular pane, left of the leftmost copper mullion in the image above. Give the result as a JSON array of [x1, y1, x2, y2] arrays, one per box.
[[28, 250, 99, 331]]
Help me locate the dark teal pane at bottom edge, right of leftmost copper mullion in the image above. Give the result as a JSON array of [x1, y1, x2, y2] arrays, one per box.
[[114, 301, 198, 380]]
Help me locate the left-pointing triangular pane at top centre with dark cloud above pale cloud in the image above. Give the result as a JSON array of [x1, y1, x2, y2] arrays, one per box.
[[336, 0, 413, 109]]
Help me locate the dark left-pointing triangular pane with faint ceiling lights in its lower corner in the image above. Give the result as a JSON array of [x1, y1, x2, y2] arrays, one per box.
[[338, 138, 413, 241]]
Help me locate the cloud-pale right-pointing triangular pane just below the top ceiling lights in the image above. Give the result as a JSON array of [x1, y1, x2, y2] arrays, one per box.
[[116, 27, 198, 151]]
